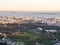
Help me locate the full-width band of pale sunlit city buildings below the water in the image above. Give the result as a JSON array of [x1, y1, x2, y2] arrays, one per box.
[[0, 16, 60, 25]]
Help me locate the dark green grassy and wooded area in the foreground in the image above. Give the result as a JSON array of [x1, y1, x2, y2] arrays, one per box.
[[6, 30, 60, 45]]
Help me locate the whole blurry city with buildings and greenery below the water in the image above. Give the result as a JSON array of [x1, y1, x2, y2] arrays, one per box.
[[0, 16, 60, 45]]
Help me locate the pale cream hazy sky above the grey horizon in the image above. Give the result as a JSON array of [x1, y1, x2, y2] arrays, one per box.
[[0, 0, 60, 11]]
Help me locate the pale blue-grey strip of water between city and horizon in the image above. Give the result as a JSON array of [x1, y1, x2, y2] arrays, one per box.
[[0, 12, 60, 17]]
